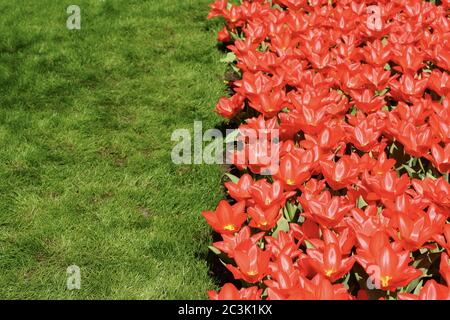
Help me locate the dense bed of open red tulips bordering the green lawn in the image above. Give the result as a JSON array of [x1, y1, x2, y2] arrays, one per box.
[[203, 0, 450, 299]]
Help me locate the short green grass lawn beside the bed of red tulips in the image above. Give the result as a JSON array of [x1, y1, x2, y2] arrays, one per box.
[[0, 0, 224, 299]]
